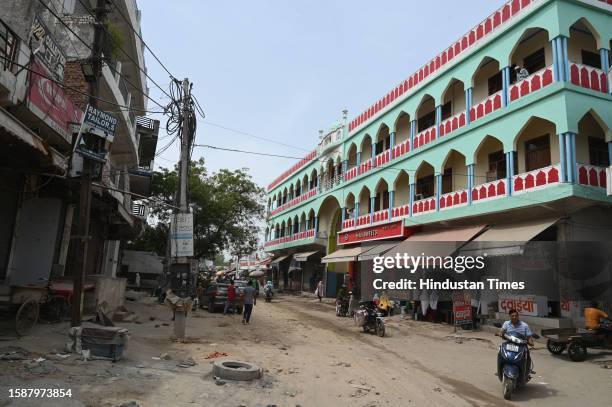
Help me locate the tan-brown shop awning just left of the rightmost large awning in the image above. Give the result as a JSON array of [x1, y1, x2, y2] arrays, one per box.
[[385, 225, 486, 257]]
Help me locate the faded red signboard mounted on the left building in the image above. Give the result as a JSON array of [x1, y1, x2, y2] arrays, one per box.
[[28, 60, 83, 144]]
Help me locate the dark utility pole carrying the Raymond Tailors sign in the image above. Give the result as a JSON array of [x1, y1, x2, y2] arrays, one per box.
[[70, 0, 108, 326]]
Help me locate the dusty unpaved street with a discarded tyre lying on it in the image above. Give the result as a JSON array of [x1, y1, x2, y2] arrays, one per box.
[[0, 296, 612, 407]]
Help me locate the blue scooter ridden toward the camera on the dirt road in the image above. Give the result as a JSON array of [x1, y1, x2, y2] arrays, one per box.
[[495, 324, 539, 400]]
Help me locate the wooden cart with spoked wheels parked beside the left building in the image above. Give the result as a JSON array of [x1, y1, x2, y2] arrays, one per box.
[[0, 284, 70, 336]]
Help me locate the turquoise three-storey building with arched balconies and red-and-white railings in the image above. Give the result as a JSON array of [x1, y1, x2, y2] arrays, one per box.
[[265, 0, 612, 318]]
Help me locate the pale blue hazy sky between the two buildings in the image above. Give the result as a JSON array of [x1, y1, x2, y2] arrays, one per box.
[[138, 0, 505, 187]]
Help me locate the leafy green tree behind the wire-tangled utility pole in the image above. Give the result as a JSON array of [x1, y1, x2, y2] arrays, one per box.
[[130, 158, 264, 259]]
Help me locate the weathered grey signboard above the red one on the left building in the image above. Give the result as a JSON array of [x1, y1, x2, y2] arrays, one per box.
[[30, 16, 66, 82]]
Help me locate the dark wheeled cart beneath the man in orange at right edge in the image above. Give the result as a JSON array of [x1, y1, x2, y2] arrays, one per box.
[[542, 328, 612, 362]]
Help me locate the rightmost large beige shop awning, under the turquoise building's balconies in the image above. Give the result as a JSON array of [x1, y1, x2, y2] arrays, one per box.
[[461, 218, 559, 256]]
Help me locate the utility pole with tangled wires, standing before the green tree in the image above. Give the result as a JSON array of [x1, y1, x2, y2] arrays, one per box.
[[174, 78, 195, 339]]
